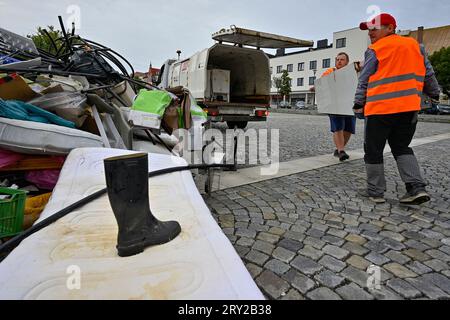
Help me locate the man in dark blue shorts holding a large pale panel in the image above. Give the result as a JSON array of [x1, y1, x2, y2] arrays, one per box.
[[322, 52, 356, 162]]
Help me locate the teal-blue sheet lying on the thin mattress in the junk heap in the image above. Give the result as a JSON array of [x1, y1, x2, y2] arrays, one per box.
[[0, 99, 75, 128]]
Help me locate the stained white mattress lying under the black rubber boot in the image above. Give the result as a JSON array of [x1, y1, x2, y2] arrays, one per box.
[[0, 149, 264, 300]]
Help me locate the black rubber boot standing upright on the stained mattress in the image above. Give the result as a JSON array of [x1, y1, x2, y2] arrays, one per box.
[[104, 153, 181, 257]]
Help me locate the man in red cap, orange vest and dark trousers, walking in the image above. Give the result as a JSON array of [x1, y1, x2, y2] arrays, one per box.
[[353, 13, 440, 205]]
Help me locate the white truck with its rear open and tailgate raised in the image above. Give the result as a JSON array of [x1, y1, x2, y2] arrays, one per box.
[[158, 26, 314, 129]]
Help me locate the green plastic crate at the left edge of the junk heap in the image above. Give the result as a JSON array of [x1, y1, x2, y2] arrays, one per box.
[[0, 188, 27, 238]]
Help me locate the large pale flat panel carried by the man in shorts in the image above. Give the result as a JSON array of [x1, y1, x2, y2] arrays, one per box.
[[315, 64, 358, 116]]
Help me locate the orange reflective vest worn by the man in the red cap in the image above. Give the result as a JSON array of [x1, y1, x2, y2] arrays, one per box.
[[364, 35, 426, 116]]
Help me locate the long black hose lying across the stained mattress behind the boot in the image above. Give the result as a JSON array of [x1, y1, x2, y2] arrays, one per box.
[[0, 164, 234, 255]]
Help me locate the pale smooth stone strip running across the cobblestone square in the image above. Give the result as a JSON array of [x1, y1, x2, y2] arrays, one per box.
[[213, 133, 450, 191]]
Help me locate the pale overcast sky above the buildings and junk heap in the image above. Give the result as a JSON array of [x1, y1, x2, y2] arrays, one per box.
[[0, 0, 450, 71]]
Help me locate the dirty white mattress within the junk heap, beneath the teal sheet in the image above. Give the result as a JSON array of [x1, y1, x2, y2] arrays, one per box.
[[0, 118, 103, 155]]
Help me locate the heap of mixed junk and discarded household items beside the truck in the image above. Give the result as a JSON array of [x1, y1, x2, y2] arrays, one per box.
[[0, 17, 206, 238]]
